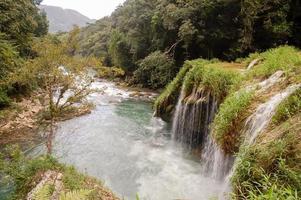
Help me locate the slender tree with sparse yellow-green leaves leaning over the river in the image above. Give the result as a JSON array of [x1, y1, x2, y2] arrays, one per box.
[[15, 36, 92, 154]]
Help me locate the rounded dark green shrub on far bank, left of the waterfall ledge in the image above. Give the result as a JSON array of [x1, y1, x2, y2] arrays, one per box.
[[133, 51, 177, 89]]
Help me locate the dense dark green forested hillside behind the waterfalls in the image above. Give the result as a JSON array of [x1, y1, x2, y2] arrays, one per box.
[[81, 0, 301, 87]]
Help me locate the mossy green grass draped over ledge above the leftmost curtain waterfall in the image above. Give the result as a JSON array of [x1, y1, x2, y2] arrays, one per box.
[[154, 59, 241, 117]]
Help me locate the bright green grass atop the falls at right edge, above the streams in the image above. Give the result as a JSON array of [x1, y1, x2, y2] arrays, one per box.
[[247, 46, 301, 78]]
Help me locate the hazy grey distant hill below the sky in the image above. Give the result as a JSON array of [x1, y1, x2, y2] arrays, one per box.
[[39, 5, 95, 33]]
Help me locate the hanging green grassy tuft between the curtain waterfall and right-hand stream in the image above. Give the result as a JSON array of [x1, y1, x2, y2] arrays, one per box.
[[212, 89, 254, 153]]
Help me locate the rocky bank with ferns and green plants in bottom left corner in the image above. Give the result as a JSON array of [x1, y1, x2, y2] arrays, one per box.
[[0, 148, 119, 200]]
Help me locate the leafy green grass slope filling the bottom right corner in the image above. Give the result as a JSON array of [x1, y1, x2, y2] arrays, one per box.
[[232, 115, 301, 200]]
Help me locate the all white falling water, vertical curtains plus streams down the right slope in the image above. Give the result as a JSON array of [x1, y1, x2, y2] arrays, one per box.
[[173, 71, 301, 199]]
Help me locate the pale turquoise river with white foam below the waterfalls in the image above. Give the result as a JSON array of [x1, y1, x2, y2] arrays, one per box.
[[34, 81, 222, 200]]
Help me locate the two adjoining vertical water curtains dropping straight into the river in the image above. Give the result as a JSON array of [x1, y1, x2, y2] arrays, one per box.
[[172, 85, 234, 179]]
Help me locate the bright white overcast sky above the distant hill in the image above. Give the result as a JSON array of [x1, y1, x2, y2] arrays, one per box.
[[42, 0, 125, 19]]
